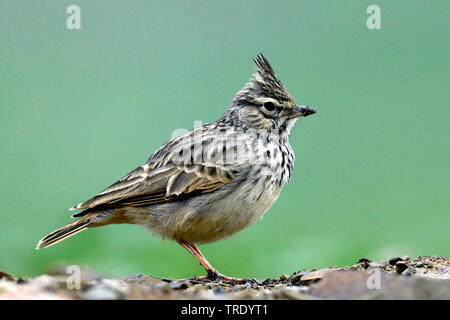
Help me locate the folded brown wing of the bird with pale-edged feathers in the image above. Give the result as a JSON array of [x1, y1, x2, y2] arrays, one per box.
[[71, 124, 239, 212]]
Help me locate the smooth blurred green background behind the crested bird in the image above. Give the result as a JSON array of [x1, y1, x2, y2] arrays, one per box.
[[0, 0, 450, 278]]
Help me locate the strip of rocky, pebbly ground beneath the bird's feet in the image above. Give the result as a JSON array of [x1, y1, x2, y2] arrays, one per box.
[[0, 256, 450, 300]]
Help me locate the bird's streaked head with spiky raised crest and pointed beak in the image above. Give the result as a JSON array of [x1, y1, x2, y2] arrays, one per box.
[[230, 54, 316, 134]]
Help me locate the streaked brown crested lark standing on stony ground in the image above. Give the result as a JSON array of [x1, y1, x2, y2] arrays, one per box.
[[36, 53, 316, 282]]
